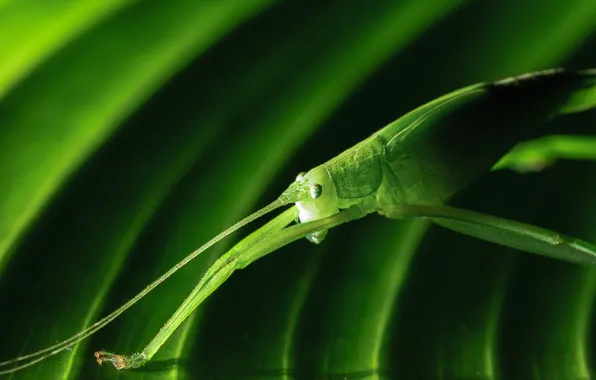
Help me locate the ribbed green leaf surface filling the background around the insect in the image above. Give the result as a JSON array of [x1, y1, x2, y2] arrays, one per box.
[[0, 0, 596, 380]]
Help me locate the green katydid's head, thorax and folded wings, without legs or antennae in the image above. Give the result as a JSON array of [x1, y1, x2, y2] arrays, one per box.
[[282, 70, 594, 243]]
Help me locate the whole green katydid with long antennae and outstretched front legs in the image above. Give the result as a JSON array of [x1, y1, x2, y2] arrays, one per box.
[[0, 69, 596, 374]]
